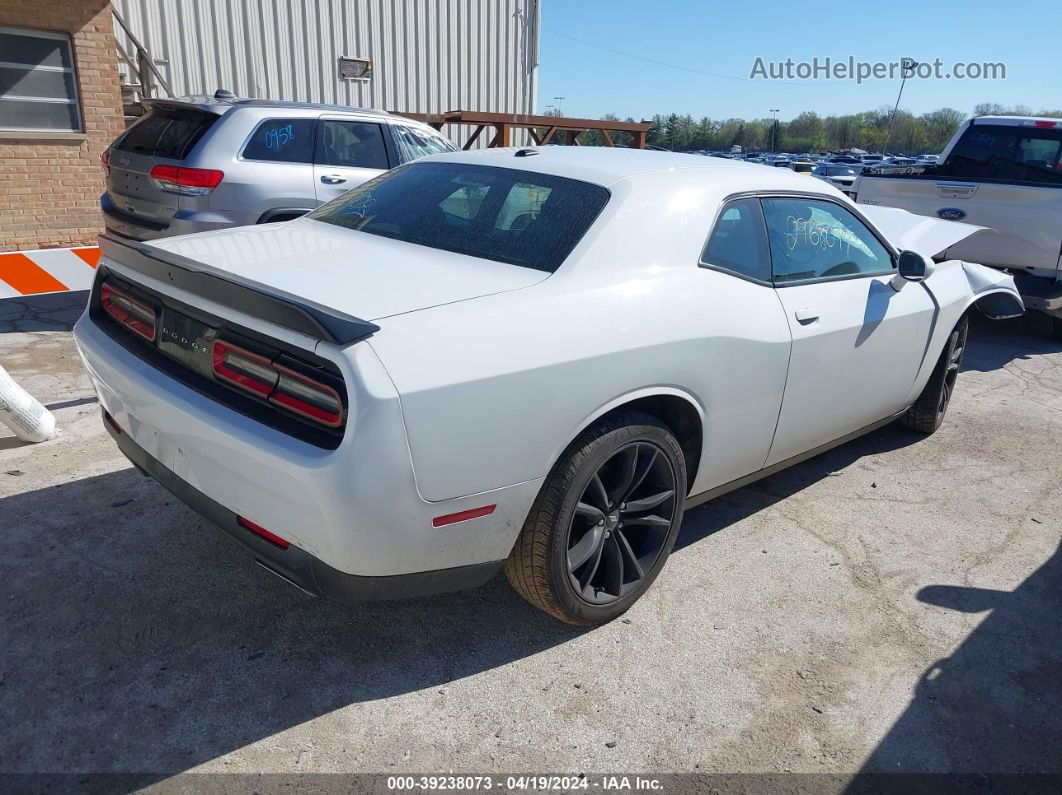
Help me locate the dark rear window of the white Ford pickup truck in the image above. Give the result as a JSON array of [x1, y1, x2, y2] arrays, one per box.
[[933, 124, 1062, 185]]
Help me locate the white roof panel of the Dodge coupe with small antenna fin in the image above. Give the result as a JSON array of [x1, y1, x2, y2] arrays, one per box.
[[426, 145, 824, 189]]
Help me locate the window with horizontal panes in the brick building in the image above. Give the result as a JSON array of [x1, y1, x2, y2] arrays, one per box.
[[0, 28, 84, 133]]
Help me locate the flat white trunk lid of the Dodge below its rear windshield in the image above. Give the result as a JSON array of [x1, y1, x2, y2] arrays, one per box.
[[148, 219, 549, 321]]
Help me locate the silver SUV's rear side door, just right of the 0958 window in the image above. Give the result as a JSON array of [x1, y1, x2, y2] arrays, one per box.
[[313, 116, 391, 202]]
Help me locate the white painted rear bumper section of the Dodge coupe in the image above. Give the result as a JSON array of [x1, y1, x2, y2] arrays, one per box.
[[74, 307, 541, 577]]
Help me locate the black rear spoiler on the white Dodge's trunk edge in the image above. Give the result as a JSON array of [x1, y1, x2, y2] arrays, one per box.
[[100, 235, 380, 345]]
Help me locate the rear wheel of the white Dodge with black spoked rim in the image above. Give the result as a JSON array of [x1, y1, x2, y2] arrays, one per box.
[[506, 411, 686, 626]]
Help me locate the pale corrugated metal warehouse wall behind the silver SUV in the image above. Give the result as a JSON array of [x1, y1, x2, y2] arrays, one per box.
[[114, 0, 539, 127]]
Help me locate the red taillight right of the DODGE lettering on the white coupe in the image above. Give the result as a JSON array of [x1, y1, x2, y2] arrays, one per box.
[[207, 340, 343, 428]]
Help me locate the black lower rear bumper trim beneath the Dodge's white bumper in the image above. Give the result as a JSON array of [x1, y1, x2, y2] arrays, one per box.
[[103, 412, 504, 604]]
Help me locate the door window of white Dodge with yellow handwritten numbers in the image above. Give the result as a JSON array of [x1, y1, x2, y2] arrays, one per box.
[[763, 198, 893, 284]]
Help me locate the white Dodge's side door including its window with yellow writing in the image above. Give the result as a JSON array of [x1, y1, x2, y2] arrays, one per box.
[[760, 195, 935, 466]]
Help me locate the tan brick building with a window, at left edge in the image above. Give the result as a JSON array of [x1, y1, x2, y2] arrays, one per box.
[[0, 0, 124, 250]]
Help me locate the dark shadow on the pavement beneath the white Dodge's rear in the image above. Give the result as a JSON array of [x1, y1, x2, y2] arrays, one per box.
[[0, 469, 582, 791]]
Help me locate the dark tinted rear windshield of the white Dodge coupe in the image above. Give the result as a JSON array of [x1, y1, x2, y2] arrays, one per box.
[[308, 162, 609, 272]]
